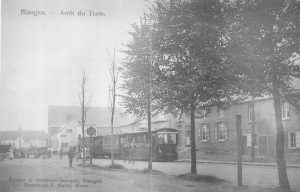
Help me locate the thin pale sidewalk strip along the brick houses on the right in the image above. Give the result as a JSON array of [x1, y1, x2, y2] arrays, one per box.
[[177, 159, 300, 168]]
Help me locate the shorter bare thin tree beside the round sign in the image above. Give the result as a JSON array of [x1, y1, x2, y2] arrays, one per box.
[[79, 69, 91, 164]]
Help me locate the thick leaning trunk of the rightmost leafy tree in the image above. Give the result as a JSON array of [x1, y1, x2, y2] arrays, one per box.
[[273, 83, 290, 190]]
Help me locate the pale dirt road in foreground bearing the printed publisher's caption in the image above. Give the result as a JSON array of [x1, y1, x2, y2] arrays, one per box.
[[0, 159, 296, 192]]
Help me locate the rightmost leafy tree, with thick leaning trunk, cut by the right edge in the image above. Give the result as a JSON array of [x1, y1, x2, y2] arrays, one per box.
[[226, 0, 300, 190]]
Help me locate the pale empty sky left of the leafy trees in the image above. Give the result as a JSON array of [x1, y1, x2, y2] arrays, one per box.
[[0, 0, 145, 131]]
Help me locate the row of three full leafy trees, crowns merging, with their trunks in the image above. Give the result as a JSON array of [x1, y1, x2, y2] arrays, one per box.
[[121, 0, 300, 189]]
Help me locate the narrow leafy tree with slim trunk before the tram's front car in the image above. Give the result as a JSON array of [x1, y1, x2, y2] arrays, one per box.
[[121, 17, 160, 170]]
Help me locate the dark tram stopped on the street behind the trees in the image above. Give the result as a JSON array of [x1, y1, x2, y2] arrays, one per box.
[[83, 128, 178, 161]]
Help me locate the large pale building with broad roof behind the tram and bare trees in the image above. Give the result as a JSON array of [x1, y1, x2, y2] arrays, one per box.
[[48, 106, 134, 151]]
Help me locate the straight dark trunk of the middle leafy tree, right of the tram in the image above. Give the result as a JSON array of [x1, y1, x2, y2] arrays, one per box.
[[191, 104, 197, 175]]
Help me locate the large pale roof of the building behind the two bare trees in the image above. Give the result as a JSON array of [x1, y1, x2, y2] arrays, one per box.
[[48, 106, 135, 127]]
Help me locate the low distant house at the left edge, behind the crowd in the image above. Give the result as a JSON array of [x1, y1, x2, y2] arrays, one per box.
[[0, 130, 47, 149]]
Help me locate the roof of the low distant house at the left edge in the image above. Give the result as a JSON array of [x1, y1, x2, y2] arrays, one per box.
[[0, 130, 47, 141]]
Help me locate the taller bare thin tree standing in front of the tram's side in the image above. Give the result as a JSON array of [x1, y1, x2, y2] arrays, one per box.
[[109, 49, 118, 165]]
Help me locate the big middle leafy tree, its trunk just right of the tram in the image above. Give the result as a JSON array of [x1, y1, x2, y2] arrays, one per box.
[[151, 0, 235, 174]]
